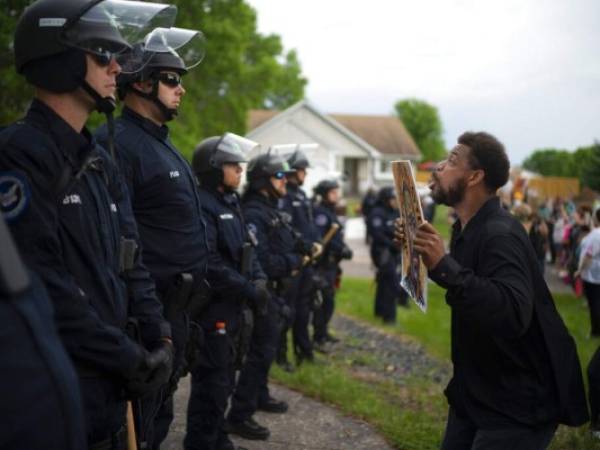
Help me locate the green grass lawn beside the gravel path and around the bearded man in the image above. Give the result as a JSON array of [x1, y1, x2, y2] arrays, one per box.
[[272, 278, 600, 450]]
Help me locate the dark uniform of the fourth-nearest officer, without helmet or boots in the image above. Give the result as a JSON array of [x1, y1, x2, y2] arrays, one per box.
[[229, 191, 302, 424]]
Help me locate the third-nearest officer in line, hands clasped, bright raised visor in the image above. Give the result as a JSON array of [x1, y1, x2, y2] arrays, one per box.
[[184, 133, 270, 450]]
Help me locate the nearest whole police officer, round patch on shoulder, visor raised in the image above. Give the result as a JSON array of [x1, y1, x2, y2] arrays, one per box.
[[0, 0, 175, 449]]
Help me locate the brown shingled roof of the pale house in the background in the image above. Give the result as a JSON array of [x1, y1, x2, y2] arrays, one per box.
[[247, 102, 421, 159]]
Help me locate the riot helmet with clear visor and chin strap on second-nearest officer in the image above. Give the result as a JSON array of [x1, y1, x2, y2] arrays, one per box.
[[117, 28, 206, 121]]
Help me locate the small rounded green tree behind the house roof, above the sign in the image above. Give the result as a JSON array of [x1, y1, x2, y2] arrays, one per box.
[[395, 98, 446, 161]]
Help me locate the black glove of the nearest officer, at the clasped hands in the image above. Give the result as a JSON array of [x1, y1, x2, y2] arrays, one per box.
[[125, 341, 173, 398]]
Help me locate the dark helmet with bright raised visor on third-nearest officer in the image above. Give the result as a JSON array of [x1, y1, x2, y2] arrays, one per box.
[[192, 133, 260, 188]]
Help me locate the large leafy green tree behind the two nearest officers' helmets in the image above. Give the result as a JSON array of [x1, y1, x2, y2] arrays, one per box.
[[0, 0, 307, 156]]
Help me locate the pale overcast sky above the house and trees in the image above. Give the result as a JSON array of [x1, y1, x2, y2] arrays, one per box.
[[248, 0, 600, 163]]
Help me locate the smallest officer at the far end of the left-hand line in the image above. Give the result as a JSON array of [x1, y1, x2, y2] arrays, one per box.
[[313, 180, 352, 350]]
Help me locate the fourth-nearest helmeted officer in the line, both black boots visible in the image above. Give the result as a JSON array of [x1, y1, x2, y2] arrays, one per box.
[[227, 152, 302, 440]]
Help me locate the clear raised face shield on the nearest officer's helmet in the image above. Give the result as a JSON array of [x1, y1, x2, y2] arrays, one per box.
[[61, 0, 177, 73]]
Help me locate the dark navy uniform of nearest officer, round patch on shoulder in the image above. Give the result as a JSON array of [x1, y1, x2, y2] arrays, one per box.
[[0, 100, 170, 447]]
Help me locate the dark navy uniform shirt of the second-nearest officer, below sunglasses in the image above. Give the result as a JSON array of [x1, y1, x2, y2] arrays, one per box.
[[96, 108, 208, 292]]
